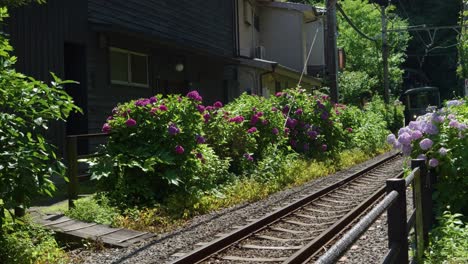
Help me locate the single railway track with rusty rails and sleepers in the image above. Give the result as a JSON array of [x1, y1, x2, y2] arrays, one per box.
[[172, 154, 402, 264]]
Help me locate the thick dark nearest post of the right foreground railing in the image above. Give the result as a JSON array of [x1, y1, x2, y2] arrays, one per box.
[[386, 179, 408, 264]]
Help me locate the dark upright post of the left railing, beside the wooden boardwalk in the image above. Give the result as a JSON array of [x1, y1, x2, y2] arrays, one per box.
[[66, 136, 78, 208]]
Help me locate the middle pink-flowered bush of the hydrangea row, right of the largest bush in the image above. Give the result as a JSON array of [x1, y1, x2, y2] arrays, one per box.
[[204, 94, 285, 173]]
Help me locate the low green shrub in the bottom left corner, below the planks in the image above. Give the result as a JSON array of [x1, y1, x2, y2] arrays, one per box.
[[0, 216, 69, 264]]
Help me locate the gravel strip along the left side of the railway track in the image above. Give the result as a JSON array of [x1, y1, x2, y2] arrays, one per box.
[[77, 153, 400, 263]]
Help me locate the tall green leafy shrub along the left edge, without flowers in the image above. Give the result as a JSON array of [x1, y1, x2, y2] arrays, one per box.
[[0, 8, 78, 223]]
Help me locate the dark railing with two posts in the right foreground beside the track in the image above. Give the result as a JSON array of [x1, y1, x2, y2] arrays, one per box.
[[316, 159, 434, 264]]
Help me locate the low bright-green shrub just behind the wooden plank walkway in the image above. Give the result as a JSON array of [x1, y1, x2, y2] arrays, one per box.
[[65, 195, 119, 225]]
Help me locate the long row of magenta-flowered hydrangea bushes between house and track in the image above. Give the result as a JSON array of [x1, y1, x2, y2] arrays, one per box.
[[90, 89, 396, 214]]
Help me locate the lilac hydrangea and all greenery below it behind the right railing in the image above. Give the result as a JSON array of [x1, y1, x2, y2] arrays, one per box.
[[388, 98, 468, 263]]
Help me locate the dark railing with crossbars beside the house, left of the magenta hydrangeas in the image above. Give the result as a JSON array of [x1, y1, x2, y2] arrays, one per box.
[[65, 133, 109, 208]]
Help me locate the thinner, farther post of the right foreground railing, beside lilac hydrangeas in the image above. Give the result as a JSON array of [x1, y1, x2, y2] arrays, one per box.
[[411, 160, 426, 263]]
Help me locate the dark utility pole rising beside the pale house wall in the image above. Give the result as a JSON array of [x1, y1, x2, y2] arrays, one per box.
[[326, 0, 338, 103]]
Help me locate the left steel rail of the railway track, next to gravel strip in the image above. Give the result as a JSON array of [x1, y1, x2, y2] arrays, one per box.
[[171, 153, 400, 264]]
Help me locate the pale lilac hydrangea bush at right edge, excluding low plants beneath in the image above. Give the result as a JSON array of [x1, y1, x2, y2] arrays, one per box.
[[387, 98, 468, 215]]
